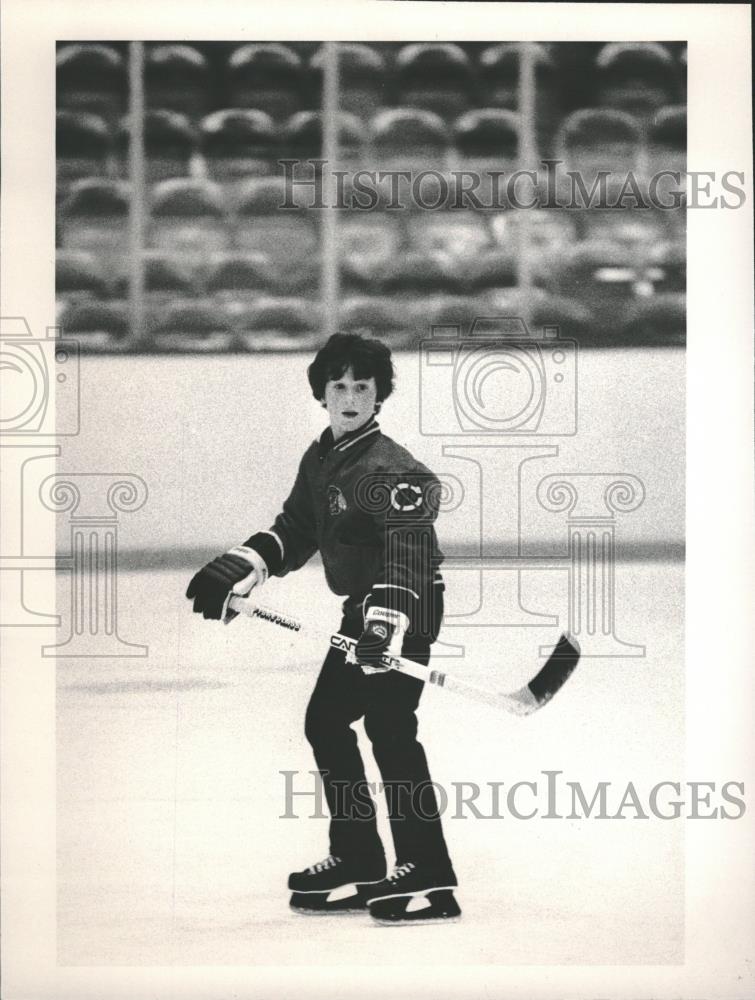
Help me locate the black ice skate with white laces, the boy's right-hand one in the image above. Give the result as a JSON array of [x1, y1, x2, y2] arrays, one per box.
[[366, 861, 461, 925]]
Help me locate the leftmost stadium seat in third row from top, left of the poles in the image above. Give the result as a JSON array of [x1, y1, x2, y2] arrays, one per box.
[[60, 178, 129, 271]]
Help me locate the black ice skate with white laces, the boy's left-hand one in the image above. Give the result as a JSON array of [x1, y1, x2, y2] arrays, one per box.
[[288, 854, 385, 914]]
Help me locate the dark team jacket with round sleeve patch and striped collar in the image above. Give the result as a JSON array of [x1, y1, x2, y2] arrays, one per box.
[[245, 418, 443, 627]]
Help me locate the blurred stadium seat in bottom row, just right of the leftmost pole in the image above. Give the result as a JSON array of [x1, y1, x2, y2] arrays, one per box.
[[149, 299, 236, 354]]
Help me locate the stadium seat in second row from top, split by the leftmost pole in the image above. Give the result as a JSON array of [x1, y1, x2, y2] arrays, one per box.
[[116, 110, 197, 184]]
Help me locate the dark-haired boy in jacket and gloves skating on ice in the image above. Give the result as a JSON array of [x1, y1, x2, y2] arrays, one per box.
[[186, 333, 461, 922]]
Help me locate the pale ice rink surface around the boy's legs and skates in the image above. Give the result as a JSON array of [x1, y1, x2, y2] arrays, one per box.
[[57, 561, 684, 966]]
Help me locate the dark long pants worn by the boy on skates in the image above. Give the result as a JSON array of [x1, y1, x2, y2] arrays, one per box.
[[305, 587, 453, 878]]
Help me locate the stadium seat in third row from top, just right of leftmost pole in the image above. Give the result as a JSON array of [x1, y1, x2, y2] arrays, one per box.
[[150, 180, 230, 265]]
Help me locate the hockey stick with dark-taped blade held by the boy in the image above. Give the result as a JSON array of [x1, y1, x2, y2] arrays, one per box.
[[223, 596, 580, 715]]
